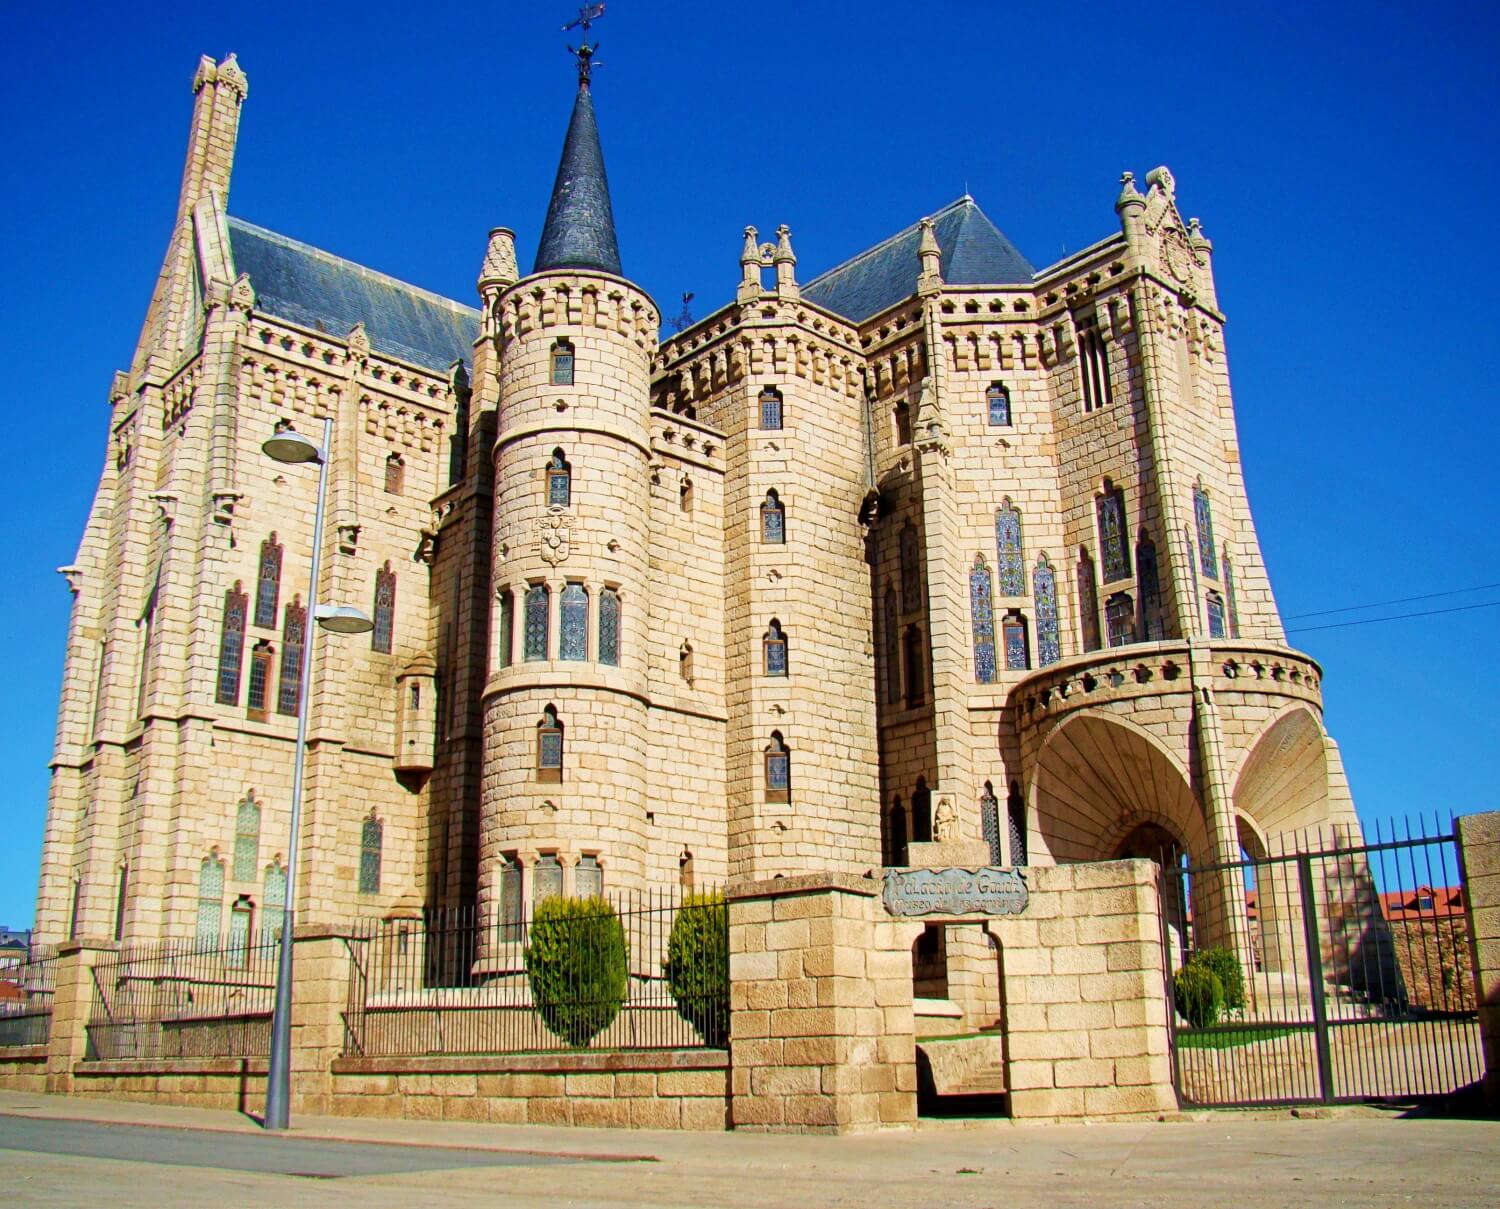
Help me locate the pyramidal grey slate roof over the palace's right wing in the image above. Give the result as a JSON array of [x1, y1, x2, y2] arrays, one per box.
[[803, 197, 1037, 323]]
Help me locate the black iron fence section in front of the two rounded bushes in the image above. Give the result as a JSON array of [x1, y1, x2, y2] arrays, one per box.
[[345, 891, 729, 1056]]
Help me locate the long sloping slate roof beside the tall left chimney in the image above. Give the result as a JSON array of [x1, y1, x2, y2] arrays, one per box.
[[228, 218, 479, 371]]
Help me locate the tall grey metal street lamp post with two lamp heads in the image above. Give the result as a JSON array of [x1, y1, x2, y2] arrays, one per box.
[[261, 419, 375, 1130]]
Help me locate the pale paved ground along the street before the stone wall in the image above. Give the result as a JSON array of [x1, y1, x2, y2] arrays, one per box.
[[0, 1092, 1500, 1209]]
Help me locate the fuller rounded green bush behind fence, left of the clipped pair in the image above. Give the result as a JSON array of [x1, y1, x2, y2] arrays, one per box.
[[527, 899, 629, 1047]]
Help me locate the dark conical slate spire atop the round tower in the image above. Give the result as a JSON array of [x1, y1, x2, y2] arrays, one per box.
[[533, 80, 621, 276]]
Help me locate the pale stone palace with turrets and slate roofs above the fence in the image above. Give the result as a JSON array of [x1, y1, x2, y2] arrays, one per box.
[[36, 56, 1358, 942]]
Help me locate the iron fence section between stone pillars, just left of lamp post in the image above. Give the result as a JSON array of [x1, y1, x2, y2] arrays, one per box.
[[87, 932, 279, 1061]]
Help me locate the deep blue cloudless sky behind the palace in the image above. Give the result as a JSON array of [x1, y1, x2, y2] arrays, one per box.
[[0, 0, 1500, 926]]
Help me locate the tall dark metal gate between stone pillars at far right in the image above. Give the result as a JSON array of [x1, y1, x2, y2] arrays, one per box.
[[1163, 824, 1484, 1107]]
